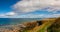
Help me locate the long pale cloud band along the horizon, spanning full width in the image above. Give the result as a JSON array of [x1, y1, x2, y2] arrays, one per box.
[[0, 12, 60, 18]]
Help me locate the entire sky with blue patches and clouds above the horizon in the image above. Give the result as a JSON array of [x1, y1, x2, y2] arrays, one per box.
[[0, 0, 60, 18]]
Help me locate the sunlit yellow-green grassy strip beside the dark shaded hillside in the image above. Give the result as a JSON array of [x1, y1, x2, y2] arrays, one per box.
[[24, 19, 55, 32]]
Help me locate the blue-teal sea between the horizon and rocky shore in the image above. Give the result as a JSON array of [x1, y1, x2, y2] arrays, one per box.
[[0, 18, 42, 26]]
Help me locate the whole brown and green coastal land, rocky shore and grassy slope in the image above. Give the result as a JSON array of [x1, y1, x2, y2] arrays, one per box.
[[0, 18, 60, 32]]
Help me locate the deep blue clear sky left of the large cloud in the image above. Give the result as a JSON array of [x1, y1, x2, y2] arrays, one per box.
[[0, 0, 20, 13]]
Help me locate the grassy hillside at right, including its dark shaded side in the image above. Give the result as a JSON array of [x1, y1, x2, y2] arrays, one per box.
[[21, 18, 60, 32]]
